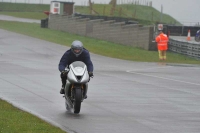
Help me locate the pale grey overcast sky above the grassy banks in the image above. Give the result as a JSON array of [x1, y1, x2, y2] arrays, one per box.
[[3, 0, 200, 23]]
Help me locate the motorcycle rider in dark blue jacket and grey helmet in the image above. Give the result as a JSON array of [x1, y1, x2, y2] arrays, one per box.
[[58, 40, 93, 98]]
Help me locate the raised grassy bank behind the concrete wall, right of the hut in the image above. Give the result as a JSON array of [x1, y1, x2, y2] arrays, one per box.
[[75, 4, 180, 25]]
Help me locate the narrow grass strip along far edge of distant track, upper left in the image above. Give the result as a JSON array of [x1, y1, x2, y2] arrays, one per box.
[[0, 12, 48, 20]]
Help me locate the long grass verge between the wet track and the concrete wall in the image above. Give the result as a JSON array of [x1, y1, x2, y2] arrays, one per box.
[[0, 21, 200, 64]]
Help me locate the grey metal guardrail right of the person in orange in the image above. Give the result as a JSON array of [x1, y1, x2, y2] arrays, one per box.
[[168, 38, 200, 60]]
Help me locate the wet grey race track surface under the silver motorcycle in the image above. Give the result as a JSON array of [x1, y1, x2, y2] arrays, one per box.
[[0, 30, 200, 133]]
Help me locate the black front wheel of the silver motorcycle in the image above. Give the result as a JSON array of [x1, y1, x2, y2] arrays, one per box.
[[74, 88, 82, 114]]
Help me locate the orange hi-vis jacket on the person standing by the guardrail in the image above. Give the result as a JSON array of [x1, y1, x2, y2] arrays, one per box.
[[156, 33, 169, 50]]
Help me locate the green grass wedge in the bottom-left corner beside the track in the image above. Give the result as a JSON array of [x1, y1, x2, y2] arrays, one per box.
[[0, 99, 65, 133]]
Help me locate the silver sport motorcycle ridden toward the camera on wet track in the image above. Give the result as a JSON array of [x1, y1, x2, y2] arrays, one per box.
[[64, 61, 90, 114]]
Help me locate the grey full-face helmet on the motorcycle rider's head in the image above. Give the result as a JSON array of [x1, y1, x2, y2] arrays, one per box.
[[71, 40, 83, 57]]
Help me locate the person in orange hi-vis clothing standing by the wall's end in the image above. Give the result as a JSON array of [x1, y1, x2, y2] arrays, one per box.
[[155, 25, 169, 60]]
